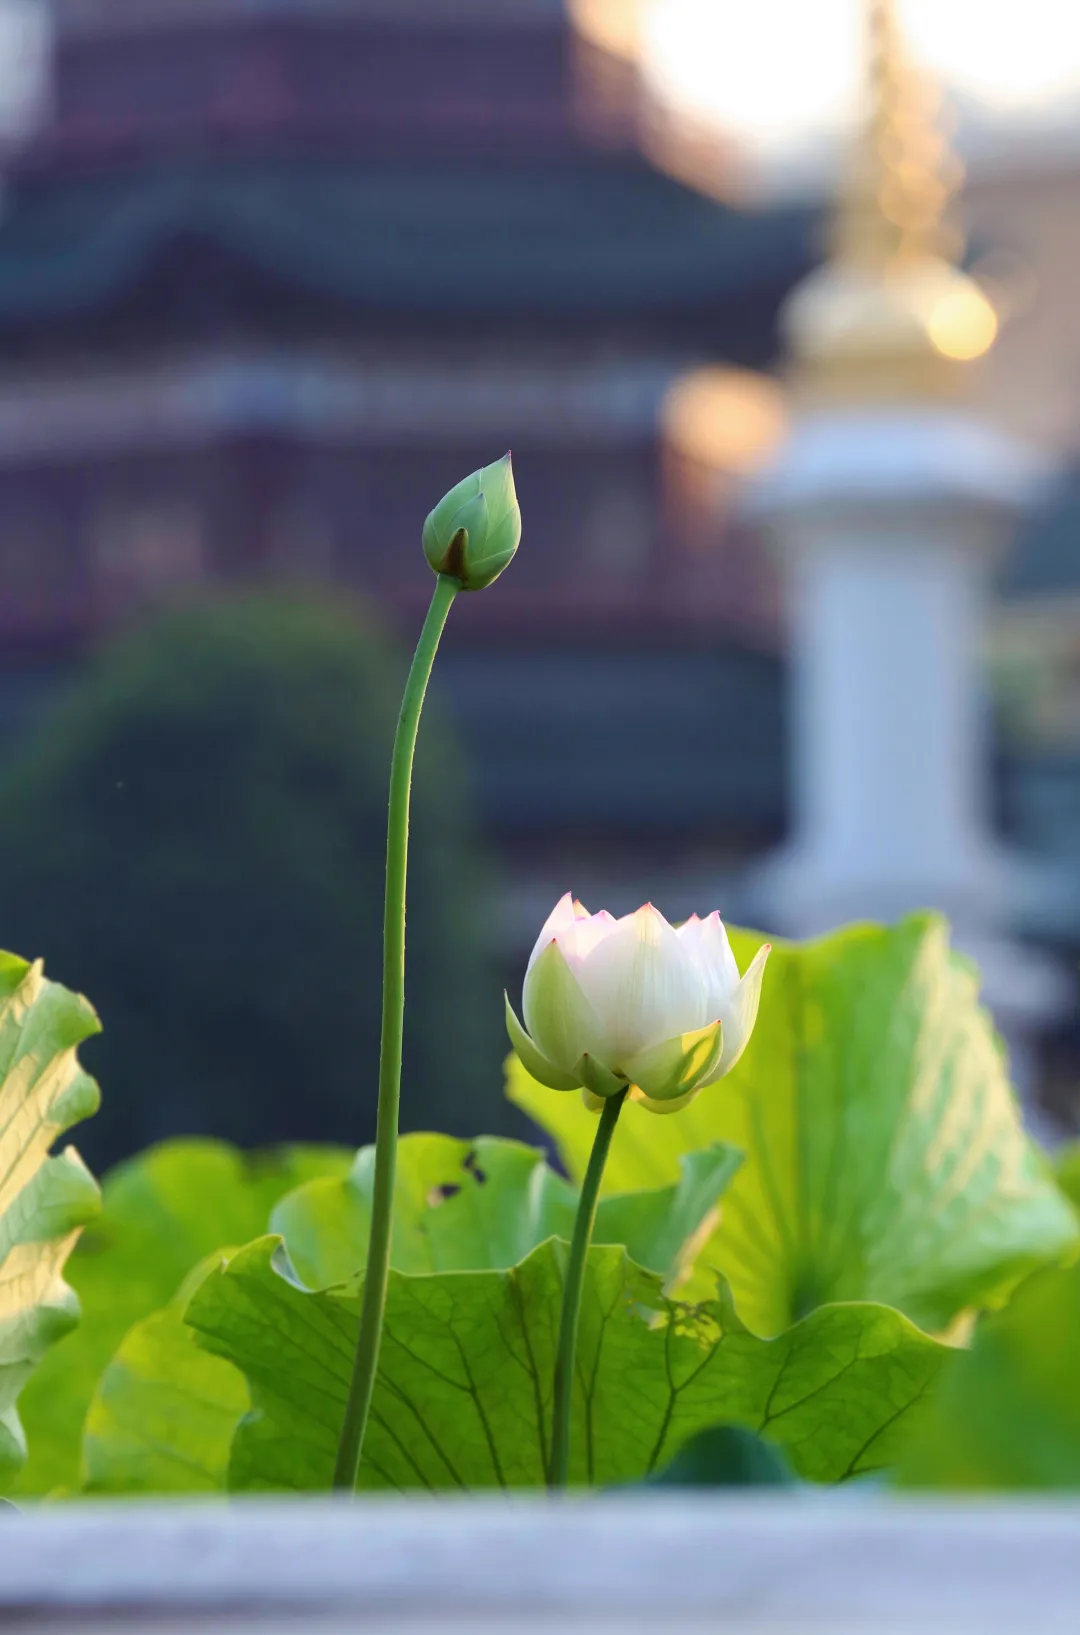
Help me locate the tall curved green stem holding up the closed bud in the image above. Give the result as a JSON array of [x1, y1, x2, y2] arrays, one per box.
[[333, 574, 461, 1493]]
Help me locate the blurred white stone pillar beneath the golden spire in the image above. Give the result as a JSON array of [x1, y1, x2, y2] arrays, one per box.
[[750, 407, 1064, 1035]]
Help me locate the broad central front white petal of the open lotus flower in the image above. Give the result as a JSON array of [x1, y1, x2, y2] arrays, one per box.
[[577, 904, 709, 1069]]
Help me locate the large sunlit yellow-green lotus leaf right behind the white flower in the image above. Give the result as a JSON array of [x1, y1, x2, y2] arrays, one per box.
[[508, 916, 1077, 1334]]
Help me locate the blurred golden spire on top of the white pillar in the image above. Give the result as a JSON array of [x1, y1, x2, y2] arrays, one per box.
[[783, 0, 997, 402]]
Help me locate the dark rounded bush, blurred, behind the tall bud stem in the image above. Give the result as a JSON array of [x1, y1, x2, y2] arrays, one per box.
[[0, 592, 508, 1167]]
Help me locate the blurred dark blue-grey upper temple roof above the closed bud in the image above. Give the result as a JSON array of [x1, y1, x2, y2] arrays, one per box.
[[0, 155, 812, 331]]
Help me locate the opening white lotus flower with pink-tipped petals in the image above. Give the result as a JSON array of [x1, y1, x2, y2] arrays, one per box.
[[507, 893, 770, 1113]]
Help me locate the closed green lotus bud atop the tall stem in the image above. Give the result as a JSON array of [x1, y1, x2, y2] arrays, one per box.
[[423, 455, 521, 590]]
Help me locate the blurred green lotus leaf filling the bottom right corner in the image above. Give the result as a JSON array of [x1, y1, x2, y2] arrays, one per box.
[[900, 1265, 1080, 1489]]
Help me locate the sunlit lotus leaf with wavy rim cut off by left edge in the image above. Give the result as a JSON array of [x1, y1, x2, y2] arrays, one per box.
[[0, 953, 100, 1488]]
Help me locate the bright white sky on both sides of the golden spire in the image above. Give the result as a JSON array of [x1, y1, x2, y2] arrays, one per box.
[[573, 0, 1080, 192]]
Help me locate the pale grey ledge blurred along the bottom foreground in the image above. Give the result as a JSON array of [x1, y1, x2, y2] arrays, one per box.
[[0, 1489, 1080, 1635]]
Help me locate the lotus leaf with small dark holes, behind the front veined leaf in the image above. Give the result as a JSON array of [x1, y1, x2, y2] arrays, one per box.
[[270, 1135, 742, 1288]]
